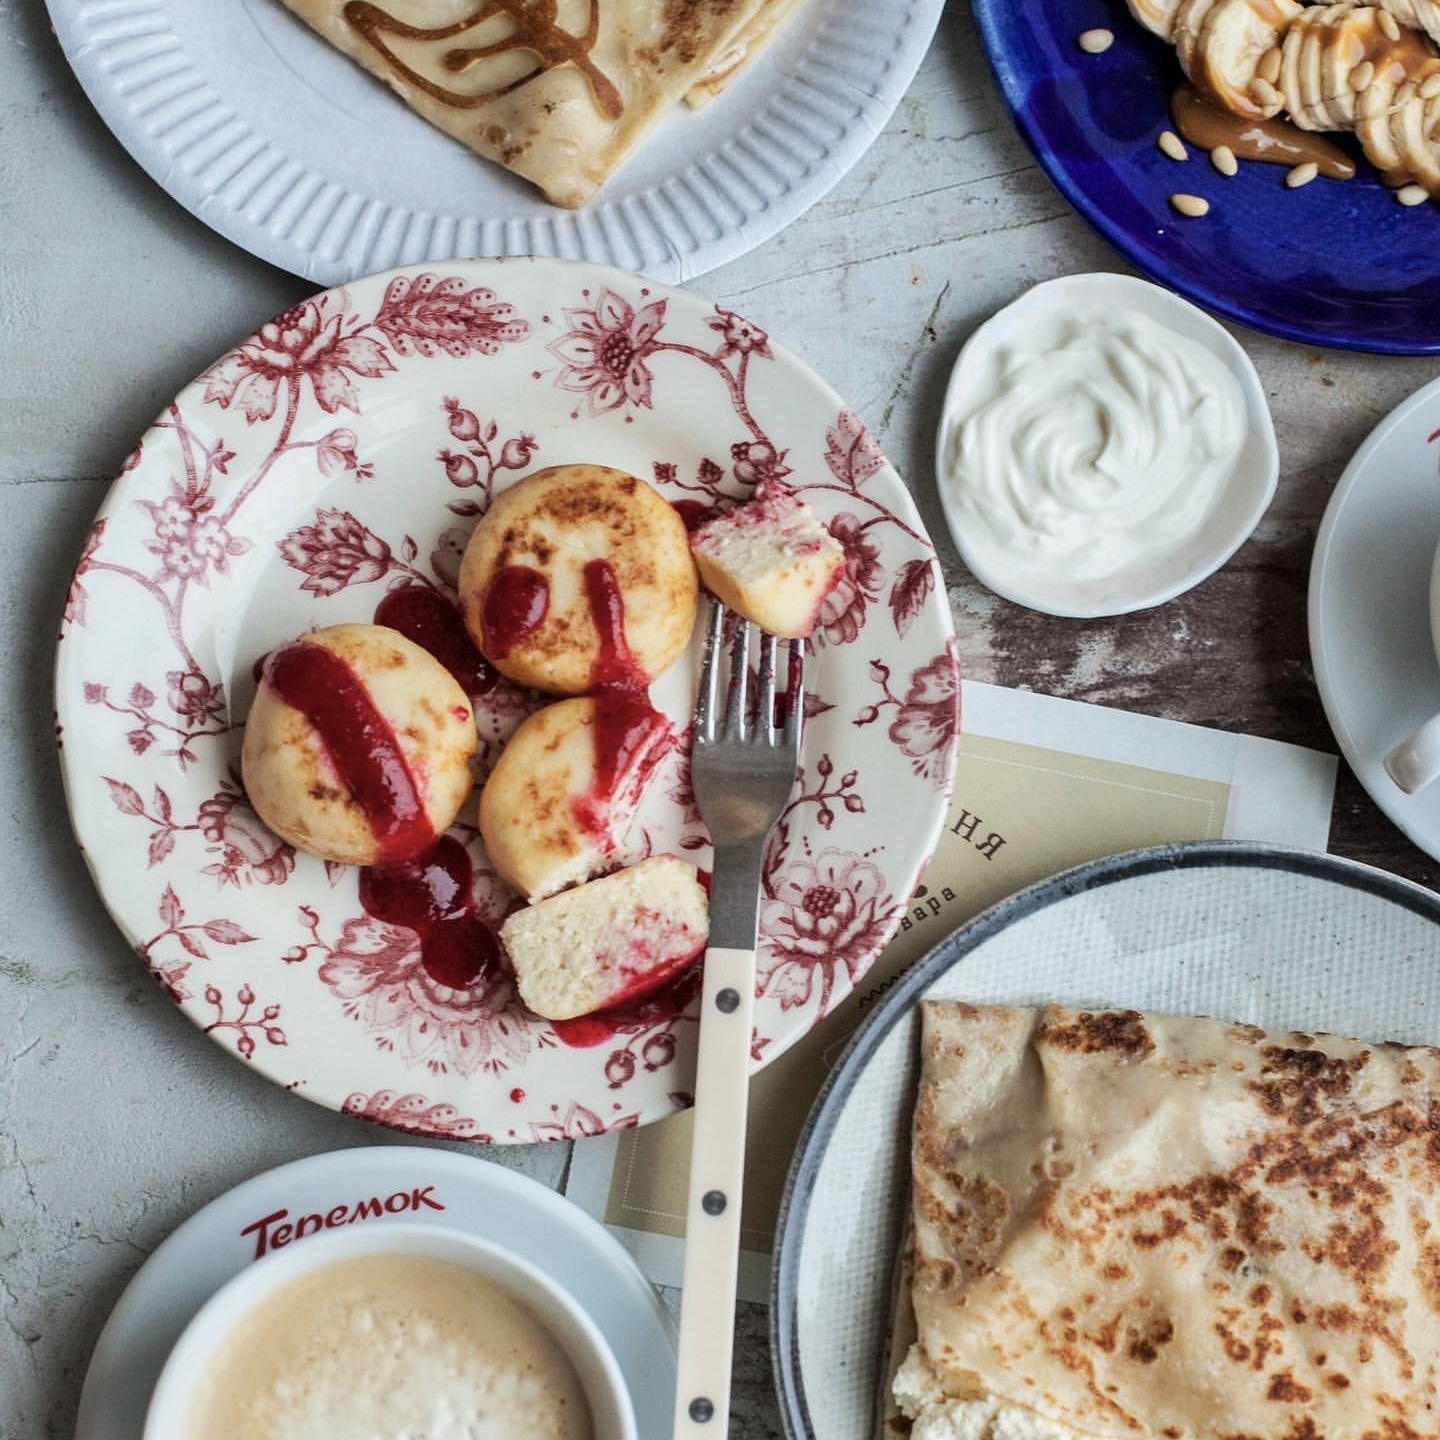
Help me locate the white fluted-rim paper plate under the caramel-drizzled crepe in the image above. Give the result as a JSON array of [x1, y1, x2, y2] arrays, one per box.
[[49, 0, 943, 285]]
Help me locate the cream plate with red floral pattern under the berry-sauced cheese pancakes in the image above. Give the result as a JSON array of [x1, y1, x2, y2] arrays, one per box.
[[56, 259, 959, 1142]]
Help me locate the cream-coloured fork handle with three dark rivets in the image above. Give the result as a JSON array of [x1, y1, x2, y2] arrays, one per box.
[[674, 946, 755, 1440]]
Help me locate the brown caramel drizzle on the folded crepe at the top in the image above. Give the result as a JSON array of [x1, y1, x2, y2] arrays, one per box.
[[344, 0, 625, 120]]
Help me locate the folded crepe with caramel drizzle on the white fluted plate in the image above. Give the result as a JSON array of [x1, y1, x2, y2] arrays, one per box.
[[270, 0, 801, 209]]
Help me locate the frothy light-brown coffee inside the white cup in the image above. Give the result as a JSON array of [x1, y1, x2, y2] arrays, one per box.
[[184, 1254, 592, 1440]]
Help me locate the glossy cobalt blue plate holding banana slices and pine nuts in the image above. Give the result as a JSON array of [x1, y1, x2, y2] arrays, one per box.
[[973, 0, 1440, 354]]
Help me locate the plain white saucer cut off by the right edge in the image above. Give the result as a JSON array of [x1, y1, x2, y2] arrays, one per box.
[[1309, 380, 1440, 860]]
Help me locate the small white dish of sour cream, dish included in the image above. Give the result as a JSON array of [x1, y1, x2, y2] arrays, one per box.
[[937, 274, 1279, 616]]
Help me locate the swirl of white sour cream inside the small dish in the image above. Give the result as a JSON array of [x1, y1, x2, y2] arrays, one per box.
[[943, 305, 1248, 580]]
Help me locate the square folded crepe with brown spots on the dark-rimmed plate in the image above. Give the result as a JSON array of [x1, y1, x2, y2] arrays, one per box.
[[894, 1001, 1440, 1440]]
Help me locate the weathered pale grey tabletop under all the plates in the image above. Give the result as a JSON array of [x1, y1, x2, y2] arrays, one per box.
[[8, 0, 1440, 1440]]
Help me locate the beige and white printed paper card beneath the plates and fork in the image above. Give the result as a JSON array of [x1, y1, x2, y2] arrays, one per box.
[[566, 681, 1338, 1300]]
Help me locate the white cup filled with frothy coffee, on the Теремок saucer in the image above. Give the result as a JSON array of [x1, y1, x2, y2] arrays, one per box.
[[144, 1221, 636, 1440]]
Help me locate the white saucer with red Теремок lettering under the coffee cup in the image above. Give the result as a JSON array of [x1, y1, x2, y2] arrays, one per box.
[[75, 1145, 675, 1440]]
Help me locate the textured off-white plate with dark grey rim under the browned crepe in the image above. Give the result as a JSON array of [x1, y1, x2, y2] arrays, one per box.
[[770, 841, 1440, 1440]]
